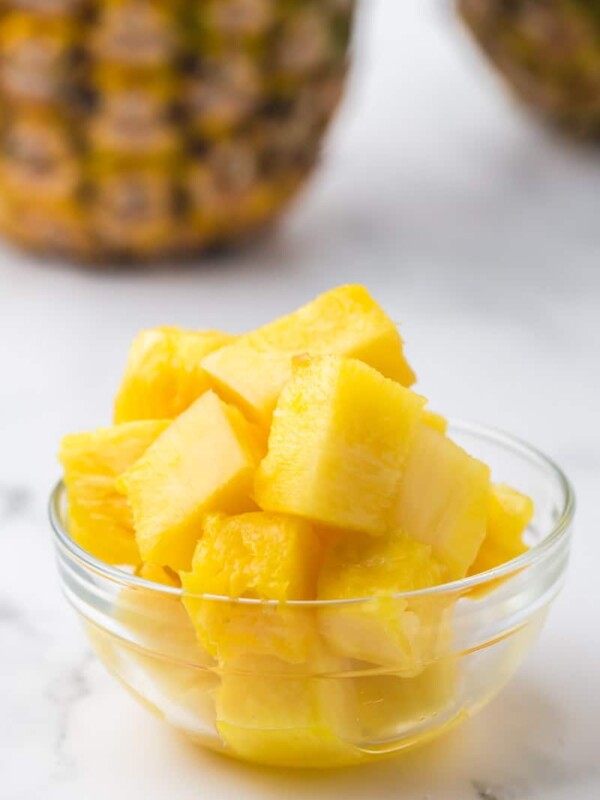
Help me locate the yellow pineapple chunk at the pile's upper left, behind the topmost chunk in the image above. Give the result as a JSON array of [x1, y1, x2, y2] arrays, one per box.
[[114, 328, 233, 422]]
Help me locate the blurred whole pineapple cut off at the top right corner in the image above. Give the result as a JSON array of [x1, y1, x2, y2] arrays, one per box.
[[457, 0, 600, 137]]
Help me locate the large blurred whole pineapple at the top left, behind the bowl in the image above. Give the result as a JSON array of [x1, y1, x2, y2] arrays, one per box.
[[0, 0, 354, 260]]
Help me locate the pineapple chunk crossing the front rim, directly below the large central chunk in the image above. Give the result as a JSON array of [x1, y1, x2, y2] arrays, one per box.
[[318, 532, 445, 675]]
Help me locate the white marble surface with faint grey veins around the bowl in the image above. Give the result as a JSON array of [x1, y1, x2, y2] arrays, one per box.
[[0, 0, 600, 800]]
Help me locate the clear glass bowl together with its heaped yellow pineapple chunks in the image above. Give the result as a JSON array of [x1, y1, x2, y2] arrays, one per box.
[[51, 286, 573, 767]]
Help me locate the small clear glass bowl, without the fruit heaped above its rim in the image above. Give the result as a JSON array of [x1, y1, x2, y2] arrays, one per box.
[[50, 423, 574, 767]]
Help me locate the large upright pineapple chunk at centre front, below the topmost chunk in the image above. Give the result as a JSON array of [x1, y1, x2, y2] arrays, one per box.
[[255, 356, 425, 535]]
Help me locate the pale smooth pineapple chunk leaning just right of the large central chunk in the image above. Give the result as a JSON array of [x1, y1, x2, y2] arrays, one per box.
[[394, 425, 490, 579]]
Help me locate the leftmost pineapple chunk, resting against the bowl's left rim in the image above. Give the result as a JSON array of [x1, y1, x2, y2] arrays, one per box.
[[59, 420, 169, 565]]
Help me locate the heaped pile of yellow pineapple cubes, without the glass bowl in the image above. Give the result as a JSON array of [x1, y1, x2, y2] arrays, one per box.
[[60, 286, 533, 762]]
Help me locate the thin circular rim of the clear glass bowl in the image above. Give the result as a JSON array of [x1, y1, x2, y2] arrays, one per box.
[[48, 418, 576, 608]]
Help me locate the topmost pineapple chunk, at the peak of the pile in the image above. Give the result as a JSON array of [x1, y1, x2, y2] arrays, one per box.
[[202, 286, 415, 426]]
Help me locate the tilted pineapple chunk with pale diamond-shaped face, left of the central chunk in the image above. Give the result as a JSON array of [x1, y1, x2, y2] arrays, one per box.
[[117, 391, 263, 570]]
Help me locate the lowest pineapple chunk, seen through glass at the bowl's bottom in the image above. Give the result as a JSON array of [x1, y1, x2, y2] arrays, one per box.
[[215, 656, 360, 767]]
